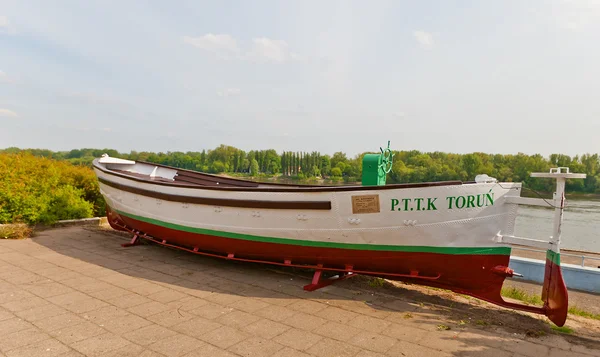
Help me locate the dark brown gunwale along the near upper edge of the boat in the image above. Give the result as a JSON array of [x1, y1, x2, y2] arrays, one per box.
[[92, 159, 470, 193]]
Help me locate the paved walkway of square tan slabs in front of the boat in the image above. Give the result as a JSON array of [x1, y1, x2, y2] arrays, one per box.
[[0, 227, 600, 357]]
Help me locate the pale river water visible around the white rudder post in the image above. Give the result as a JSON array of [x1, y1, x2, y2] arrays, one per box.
[[515, 198, 600, 253]]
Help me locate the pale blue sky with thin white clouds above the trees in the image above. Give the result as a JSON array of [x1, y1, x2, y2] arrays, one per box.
[[0, 0, 600, 156]]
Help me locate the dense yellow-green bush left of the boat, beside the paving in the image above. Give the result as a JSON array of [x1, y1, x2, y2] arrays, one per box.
[[0, 153, 105, 224]]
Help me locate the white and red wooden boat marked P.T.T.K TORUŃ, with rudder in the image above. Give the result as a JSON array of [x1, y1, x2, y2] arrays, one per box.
[[93, 143, 585, 326]]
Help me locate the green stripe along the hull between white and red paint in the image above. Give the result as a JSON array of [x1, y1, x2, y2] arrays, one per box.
[[115, 210, 510, 255]]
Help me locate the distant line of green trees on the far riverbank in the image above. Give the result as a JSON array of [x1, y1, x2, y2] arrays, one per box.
[[0, 145, 600, 194]]
